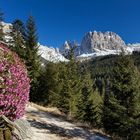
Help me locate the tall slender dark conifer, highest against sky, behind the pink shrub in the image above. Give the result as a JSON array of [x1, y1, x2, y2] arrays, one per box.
[[25, 16, 40, 101]]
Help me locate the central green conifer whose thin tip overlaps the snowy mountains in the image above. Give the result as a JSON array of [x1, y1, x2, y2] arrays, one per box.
[[59, 45, 81, 118]]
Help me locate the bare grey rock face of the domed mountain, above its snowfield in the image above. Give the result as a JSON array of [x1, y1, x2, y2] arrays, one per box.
[[80, 31, 126, 53]]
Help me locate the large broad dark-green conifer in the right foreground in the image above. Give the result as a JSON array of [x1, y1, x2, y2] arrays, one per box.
[[103, 55, 140, 140]]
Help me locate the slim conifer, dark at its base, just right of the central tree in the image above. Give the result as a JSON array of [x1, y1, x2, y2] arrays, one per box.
[[76, 68, 94, 124]]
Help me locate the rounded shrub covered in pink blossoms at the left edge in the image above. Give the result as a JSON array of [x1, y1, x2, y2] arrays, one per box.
[[0, 43, 30, 121]]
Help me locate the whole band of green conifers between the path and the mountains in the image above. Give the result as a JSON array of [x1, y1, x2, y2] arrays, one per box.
[[0, 9, 140, 140]]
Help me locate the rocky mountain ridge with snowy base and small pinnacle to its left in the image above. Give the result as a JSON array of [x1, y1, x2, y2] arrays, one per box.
[[61, 31, 140, 60]]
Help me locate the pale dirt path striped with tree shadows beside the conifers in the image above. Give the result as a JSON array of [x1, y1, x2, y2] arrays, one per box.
[[25, 105, 107, 140]]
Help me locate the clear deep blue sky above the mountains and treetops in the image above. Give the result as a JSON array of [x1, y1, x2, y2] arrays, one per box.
[[0, 0, 140, 47]]
